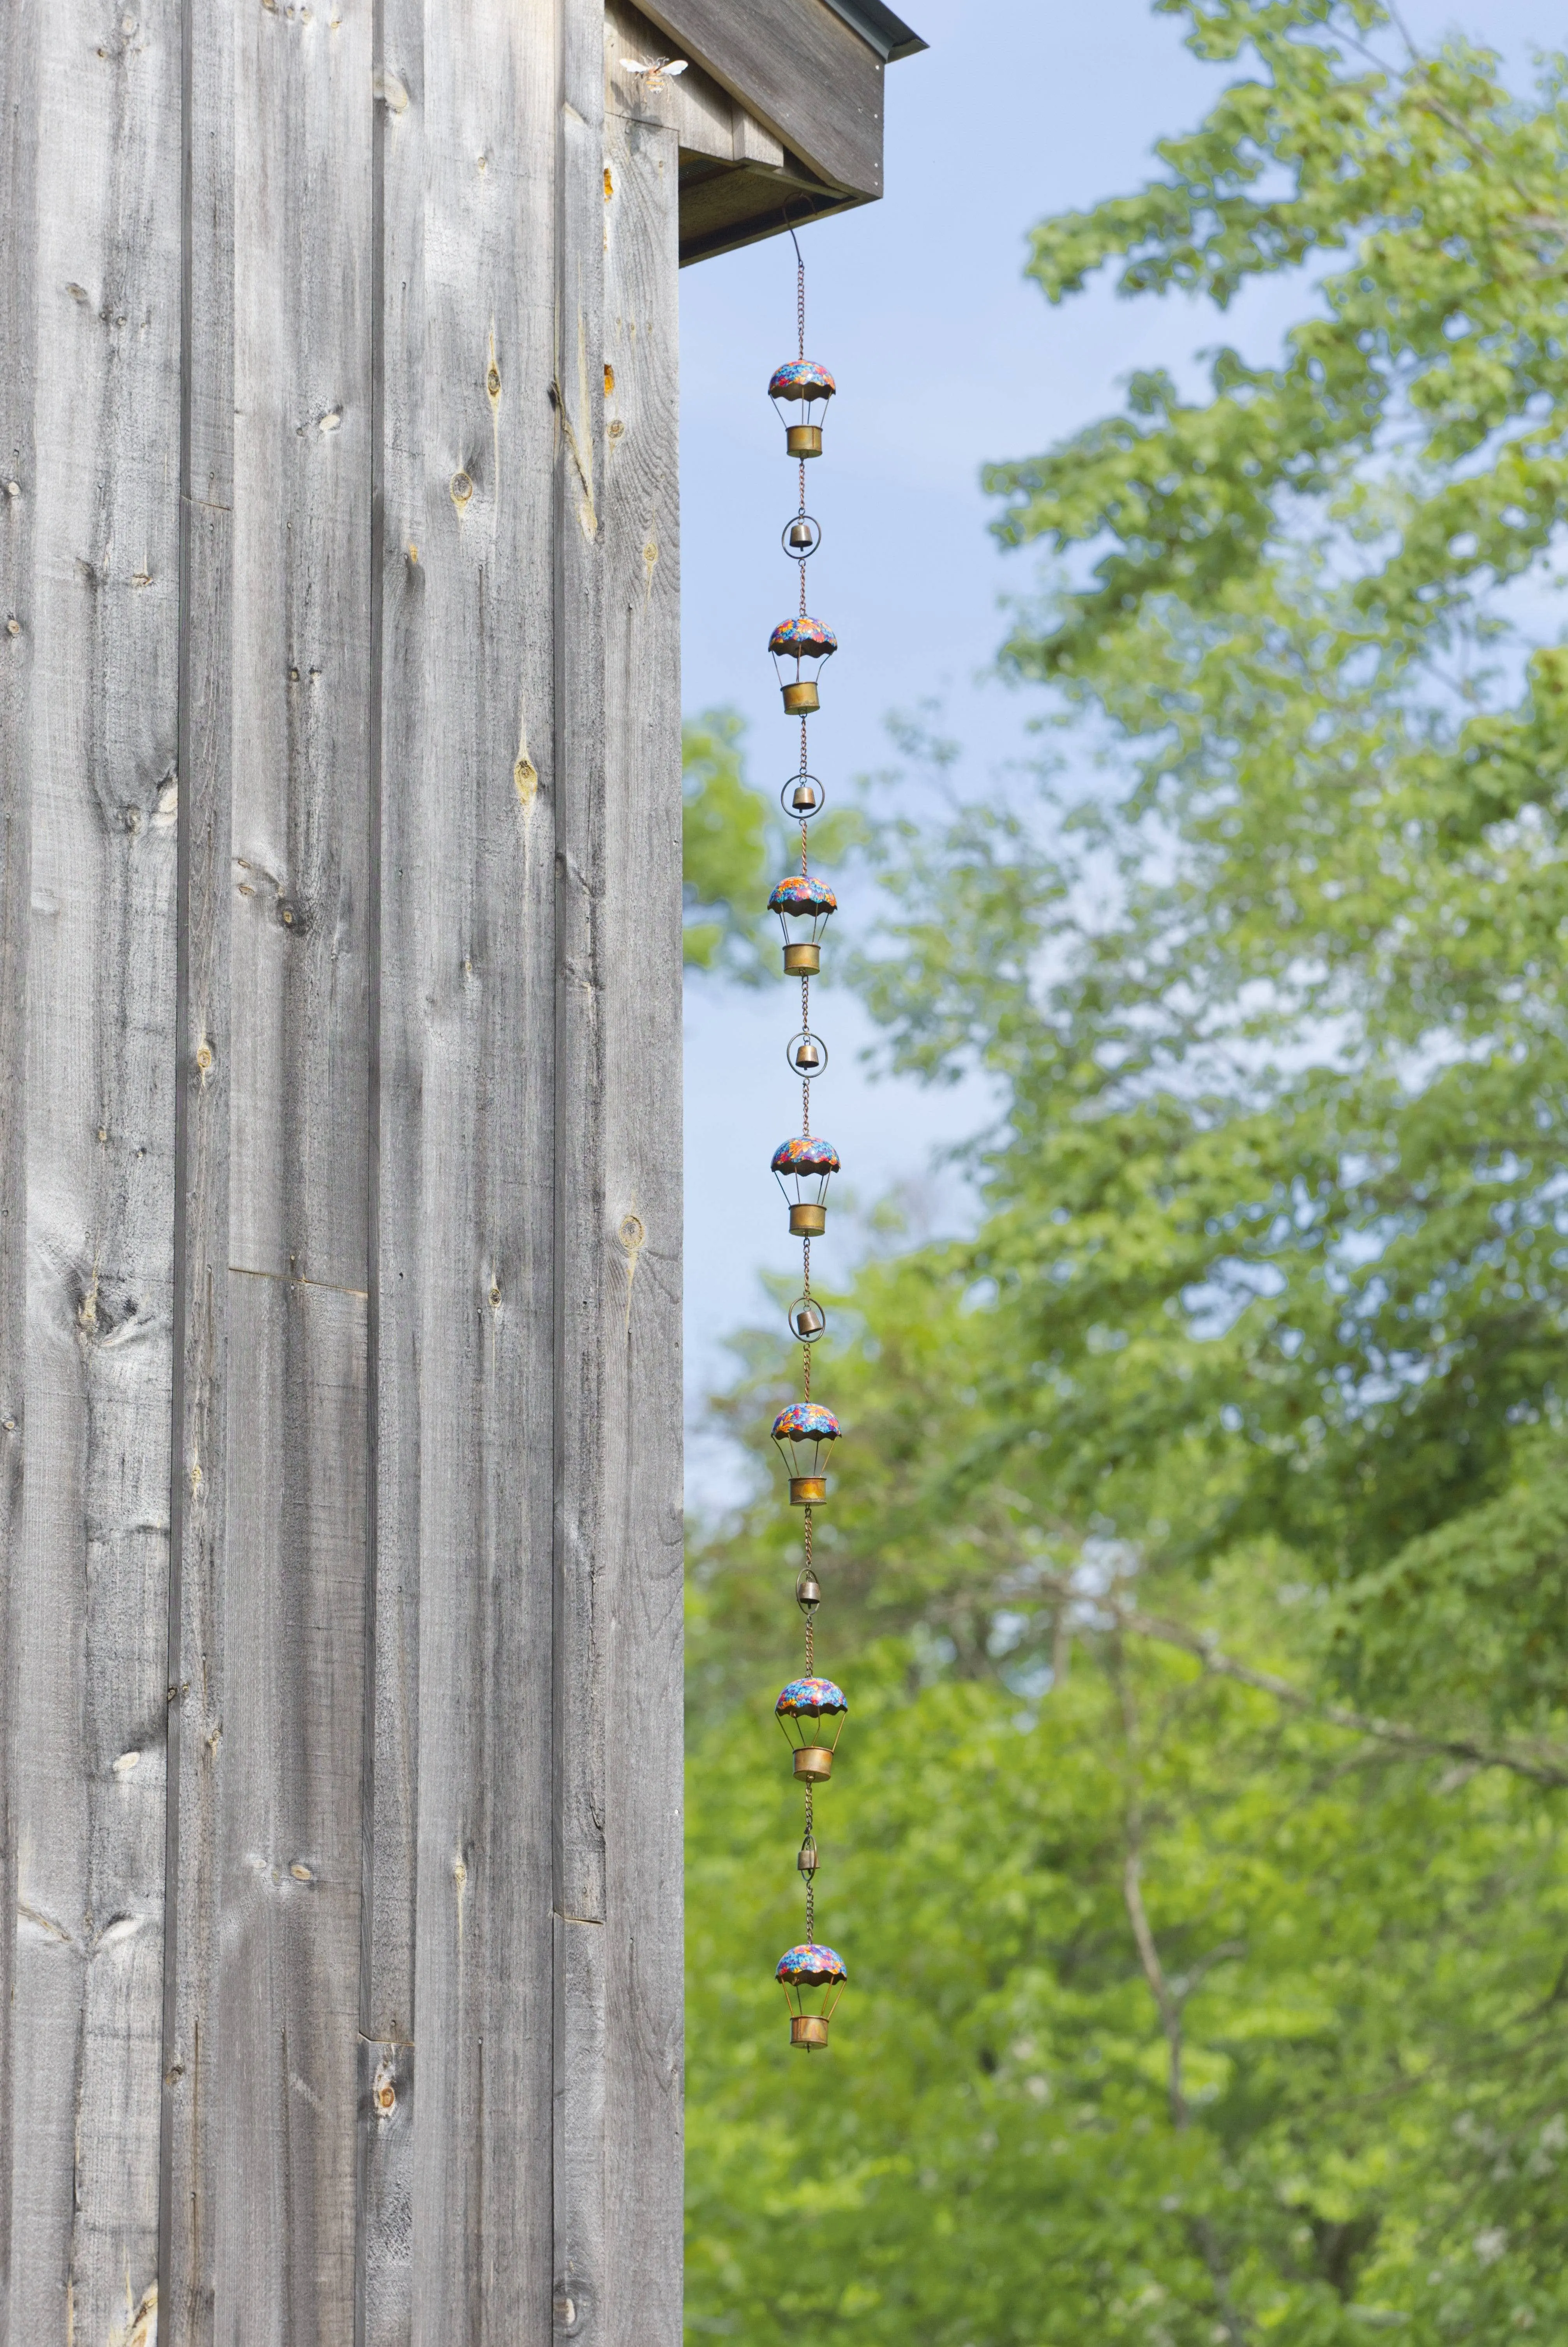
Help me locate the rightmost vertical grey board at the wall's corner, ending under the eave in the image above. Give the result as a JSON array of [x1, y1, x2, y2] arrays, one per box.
[[596, 78, 685, 2347]]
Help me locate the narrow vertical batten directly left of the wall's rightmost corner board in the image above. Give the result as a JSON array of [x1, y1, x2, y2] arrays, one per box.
[[554, 0, 610, 2340]]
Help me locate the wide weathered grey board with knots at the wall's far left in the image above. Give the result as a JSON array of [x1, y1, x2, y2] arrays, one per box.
[[0, 0, 181, 2340]]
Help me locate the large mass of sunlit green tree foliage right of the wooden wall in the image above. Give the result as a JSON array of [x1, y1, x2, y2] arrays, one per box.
[[690, 0, 1568, 2347]]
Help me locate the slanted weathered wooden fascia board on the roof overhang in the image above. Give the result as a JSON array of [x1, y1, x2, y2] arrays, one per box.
[[643, 0, 883, 197]]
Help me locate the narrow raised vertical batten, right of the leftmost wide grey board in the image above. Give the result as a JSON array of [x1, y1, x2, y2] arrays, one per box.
[[160, 0, 235, 2347]]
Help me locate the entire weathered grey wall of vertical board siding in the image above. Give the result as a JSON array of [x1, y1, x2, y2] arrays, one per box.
[[0, 0, 681, 2347]]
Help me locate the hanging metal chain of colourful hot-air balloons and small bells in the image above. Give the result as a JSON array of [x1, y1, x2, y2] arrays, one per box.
[[768, 244, 850, 2054]]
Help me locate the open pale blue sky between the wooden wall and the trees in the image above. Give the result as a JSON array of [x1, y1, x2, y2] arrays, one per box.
[[681, 0, 1568, 1504]]
